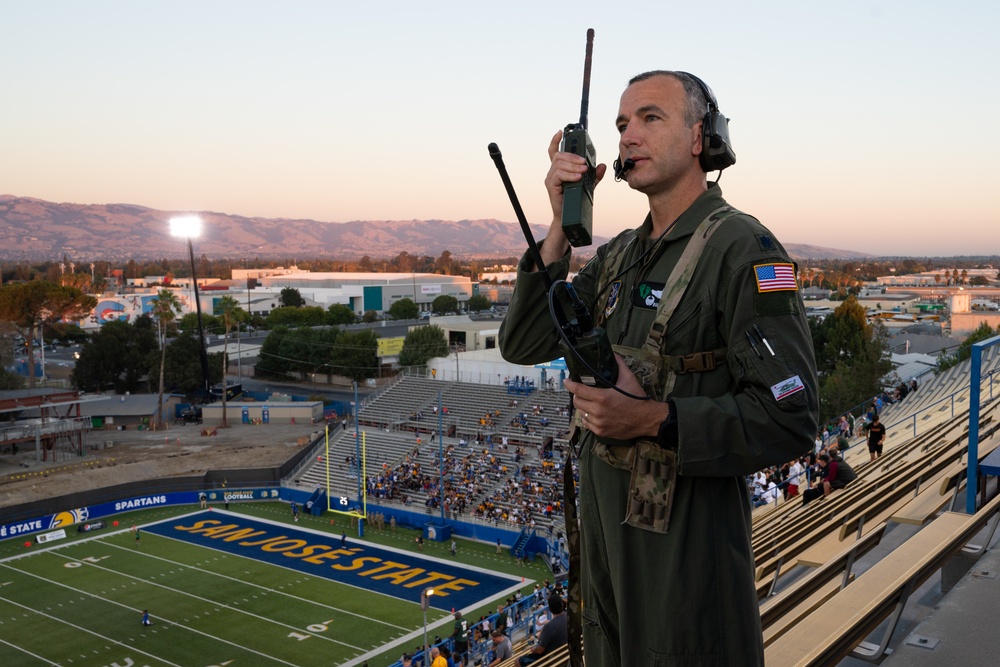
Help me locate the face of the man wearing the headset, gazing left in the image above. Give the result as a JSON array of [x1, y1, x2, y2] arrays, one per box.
[[615, 76, 701, 195]]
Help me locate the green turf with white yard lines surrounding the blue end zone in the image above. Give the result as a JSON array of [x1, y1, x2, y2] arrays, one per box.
[[0, 503, 548, 667]]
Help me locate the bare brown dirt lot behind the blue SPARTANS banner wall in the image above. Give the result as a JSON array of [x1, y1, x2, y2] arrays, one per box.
[[0, 424, 322, 507]]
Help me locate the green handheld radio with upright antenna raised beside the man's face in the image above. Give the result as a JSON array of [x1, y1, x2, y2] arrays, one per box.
[[560, 28, 597, 248]]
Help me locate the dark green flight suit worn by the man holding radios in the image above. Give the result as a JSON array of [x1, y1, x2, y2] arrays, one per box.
[[499, 184, 818, 667]]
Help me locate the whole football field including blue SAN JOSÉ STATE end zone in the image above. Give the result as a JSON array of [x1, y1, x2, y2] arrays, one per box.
[[0, 511, 523, 667]]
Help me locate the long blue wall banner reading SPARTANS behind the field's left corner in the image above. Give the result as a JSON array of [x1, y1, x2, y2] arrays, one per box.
[[0, 487, 278, 540]]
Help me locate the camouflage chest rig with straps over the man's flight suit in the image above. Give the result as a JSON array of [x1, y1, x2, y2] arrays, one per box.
[[576, 206, 739, 533]]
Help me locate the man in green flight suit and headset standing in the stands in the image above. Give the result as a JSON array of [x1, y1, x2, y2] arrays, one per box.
[[499, 71, 818, 667]]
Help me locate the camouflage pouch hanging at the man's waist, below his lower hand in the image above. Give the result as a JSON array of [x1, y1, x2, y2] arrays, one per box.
[[625, 440, 677, 533]]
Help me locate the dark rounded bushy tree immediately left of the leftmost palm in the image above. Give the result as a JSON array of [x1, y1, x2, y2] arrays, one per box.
[[70, 317, 158, 394]]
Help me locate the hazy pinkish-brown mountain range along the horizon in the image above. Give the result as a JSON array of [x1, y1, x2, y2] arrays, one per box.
[[0, 195, 868, 261]]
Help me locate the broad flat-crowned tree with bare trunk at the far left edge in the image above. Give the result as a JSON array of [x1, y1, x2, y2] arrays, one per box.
[[0, 281, 97, 387]]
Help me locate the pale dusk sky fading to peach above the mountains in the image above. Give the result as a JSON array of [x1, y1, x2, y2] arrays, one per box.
[[0, 0, 1000, 255]]
